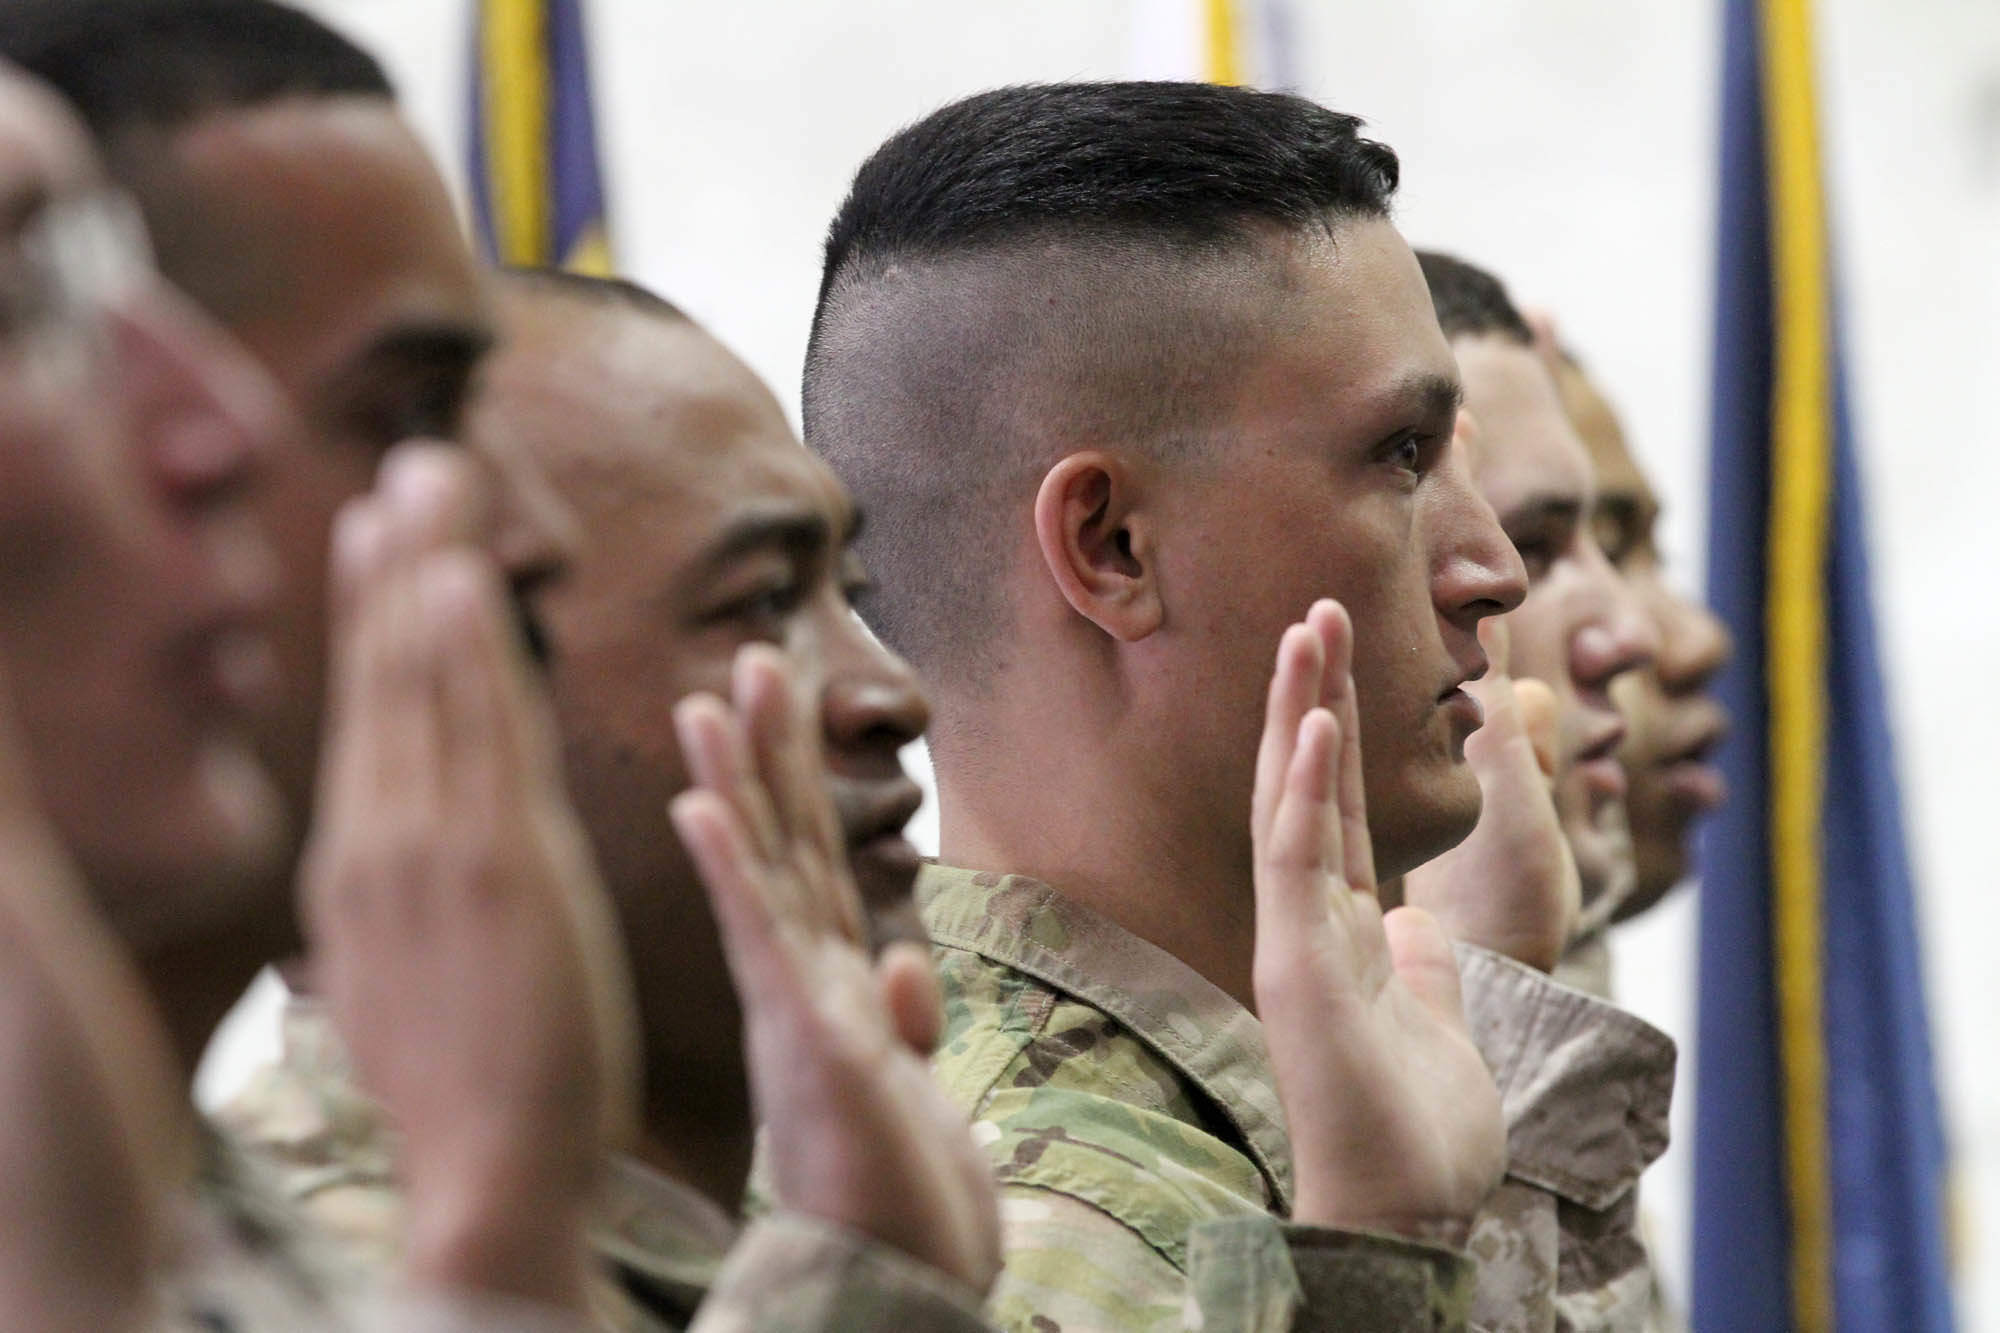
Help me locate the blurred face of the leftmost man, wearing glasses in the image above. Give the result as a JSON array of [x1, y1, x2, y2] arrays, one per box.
[[0, 72, 280, 949]]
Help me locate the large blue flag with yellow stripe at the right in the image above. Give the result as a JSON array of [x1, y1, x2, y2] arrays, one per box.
[[1694, 0, 1952, 1333]]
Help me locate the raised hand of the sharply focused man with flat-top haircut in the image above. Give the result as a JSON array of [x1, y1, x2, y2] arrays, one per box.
[[1250, 600, 1506, 1243]]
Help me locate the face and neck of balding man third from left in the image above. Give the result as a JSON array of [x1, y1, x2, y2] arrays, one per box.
[[474, 288, 928, 1081]]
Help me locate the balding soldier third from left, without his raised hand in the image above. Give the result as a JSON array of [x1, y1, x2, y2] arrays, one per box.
[[222, 274, 1016, 1329]]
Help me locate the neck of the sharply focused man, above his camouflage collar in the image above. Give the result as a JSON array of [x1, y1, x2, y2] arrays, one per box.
[[938, 700, 1256, 1009]]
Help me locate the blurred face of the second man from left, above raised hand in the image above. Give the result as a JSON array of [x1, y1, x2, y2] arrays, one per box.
[[120, 96, 504, 832]]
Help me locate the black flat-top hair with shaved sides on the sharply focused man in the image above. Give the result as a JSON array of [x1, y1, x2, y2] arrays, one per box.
[[804, 82, 1398, 683]]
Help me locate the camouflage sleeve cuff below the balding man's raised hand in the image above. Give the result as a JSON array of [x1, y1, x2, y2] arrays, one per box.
[[690, 1213, 990, 1333]]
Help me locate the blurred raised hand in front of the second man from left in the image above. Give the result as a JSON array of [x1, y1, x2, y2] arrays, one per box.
[[302, 444, 638, 1311]]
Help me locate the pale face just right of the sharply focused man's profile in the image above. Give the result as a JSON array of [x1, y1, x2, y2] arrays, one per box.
[[1454, 336, 1654, 903]]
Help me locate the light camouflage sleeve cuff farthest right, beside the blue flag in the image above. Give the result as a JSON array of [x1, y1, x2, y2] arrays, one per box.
[[1458, 932, 1674, 1333]]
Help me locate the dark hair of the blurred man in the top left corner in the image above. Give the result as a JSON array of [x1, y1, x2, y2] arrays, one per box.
[[0, 0, 396, 142]]
